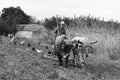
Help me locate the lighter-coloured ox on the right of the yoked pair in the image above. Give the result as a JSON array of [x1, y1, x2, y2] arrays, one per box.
[[72, 37, 97, 67]]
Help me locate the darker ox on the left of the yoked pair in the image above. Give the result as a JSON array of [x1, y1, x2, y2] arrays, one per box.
[[54, 34, 73, 67]]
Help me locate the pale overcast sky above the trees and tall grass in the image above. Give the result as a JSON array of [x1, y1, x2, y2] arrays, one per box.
[[0, 0, 120, 22]]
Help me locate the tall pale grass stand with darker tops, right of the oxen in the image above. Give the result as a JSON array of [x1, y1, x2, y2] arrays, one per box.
[[66, 16, 120, 60]]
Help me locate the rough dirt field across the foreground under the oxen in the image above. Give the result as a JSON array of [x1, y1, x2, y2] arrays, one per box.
[[0, 37, 120, 80]]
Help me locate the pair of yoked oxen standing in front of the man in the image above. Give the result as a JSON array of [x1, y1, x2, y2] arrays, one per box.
[[54, 34, 97, 68]]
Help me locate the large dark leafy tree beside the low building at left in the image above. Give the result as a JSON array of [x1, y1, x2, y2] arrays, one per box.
[[0, 7, 40, 35]]
